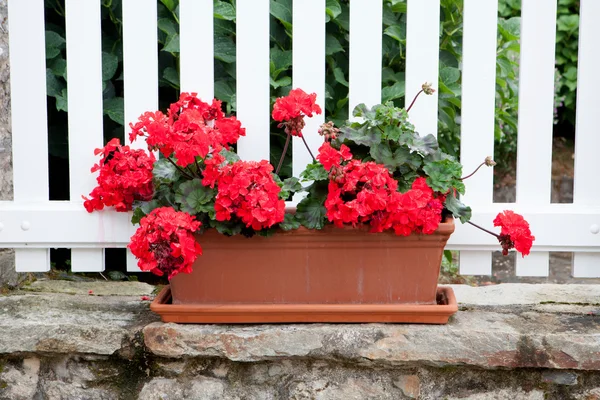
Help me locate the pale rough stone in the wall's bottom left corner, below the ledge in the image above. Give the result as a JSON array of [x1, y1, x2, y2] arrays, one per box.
[[0, 358, 40, 400]]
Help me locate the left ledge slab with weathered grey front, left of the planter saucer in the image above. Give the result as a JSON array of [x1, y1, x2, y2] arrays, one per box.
[[0, 294, 157, 354]]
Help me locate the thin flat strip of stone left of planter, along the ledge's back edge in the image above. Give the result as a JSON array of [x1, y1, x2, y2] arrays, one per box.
[[21, 280, 154, 296]]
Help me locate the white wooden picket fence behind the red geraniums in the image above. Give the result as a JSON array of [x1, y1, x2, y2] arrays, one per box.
[[0, 0, 600, 277]]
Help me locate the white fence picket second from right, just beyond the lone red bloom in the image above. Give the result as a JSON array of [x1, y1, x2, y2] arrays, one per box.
[[516, 0, 556, 276]]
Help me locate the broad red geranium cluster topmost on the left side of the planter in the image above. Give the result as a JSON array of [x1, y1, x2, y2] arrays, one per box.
[[129, 93, 246, 168]]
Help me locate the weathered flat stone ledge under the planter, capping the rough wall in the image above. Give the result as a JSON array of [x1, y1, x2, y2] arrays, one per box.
[[0, 281, 600, 371]]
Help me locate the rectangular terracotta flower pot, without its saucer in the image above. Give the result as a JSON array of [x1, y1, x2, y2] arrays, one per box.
[[170, 218, 454, 307]]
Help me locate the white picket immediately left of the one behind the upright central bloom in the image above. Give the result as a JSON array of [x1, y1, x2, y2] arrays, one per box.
[[236, 0, 270, 160]]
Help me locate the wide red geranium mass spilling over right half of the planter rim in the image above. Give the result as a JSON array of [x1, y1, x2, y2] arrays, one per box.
[[317, 142, 445, 236]]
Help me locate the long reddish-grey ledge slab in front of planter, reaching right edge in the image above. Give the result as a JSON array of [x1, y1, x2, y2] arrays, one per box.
[[144, 307, 600, 370]]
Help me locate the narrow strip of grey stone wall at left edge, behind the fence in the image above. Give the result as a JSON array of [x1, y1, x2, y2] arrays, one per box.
[[0, 0, 18, 286]]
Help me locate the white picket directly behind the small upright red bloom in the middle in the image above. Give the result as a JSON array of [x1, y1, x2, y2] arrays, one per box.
[[292, 0, 325, 176]]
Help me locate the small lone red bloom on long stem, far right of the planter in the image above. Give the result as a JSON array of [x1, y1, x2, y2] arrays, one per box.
[[494, 210, 535, 257]]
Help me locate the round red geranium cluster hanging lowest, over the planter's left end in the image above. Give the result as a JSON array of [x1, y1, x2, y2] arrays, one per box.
[[128, 207, 202, 279]]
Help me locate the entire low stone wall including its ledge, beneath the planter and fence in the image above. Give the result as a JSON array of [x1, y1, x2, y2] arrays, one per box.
[[0, 281, 600, 400]]
